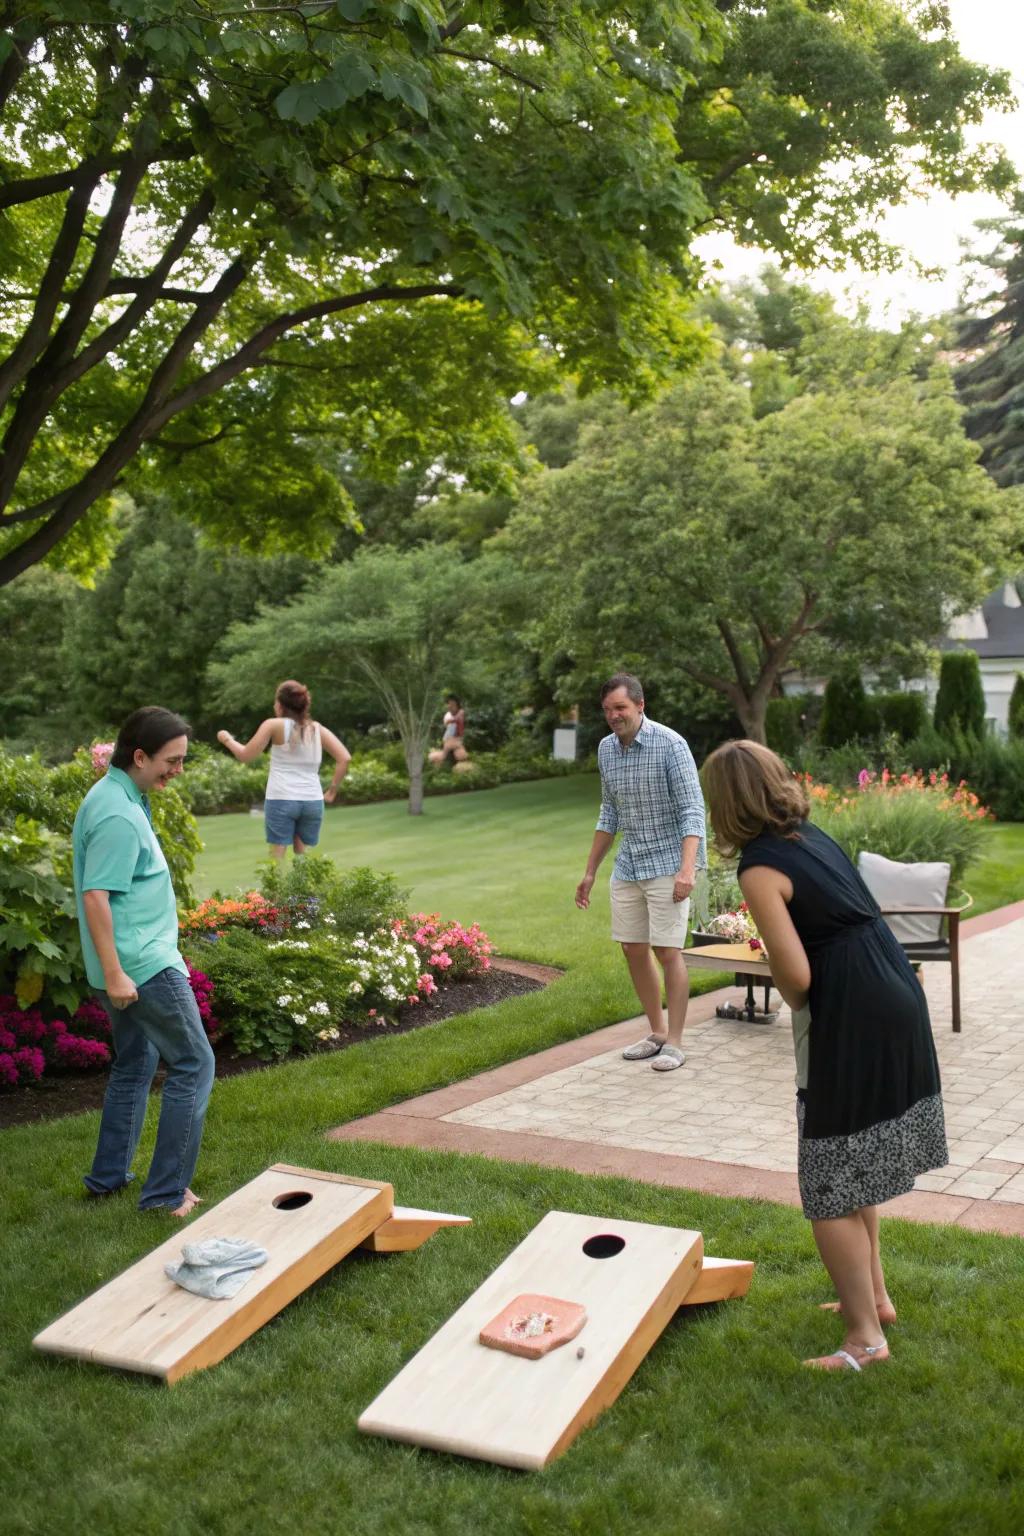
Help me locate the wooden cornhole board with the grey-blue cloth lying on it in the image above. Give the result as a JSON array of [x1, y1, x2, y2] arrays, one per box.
[[32, 1163, 468, 1382]]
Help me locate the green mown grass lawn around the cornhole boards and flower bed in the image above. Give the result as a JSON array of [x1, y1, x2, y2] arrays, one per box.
[[0, 780, 1024, 1536]]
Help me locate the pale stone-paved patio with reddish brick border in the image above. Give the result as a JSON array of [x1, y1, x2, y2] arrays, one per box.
[[332, 903, 1024, 1235]]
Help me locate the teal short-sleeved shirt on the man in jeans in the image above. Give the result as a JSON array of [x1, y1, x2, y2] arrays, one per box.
[[72, 768, 189, 989]]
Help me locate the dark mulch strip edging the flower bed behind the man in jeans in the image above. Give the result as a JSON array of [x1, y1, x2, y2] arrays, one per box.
[[0, 962, 556, 1129]]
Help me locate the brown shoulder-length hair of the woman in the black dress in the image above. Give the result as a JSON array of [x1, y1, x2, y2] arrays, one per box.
[[700, 742, 811, 859]]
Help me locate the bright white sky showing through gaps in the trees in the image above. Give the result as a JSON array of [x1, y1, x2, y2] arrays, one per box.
[[697, 0, 1024, 324]]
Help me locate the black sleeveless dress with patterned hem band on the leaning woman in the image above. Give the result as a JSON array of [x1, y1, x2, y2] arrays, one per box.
[[738, 822, 949, 1221]]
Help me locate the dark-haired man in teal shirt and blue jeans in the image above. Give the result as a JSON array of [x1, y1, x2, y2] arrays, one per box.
[[72, 707, 213, 1217]]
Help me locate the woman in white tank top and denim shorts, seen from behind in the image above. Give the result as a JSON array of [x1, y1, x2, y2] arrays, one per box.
[[216, 679, 352, 859]]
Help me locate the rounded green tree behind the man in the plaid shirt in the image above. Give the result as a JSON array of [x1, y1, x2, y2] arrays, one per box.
[[506, 296, 1022, 740]]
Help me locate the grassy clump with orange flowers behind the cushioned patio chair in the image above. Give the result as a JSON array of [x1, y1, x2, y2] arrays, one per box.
[[809, 768, 992, 885]]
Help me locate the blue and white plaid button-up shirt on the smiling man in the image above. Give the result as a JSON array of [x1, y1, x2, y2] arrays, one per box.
[[597, 714, 706, 880]]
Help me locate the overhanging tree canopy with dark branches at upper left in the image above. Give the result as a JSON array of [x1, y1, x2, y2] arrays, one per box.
[[0, 0, 1009, 584]]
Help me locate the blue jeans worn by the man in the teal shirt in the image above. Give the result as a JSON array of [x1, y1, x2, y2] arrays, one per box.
[[84, 968, 213, 1210]]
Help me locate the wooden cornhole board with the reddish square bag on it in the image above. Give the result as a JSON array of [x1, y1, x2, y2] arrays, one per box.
[[359, 1210, 754, 1468]]
